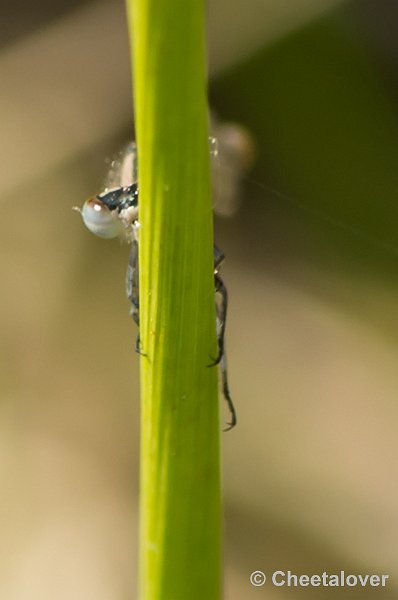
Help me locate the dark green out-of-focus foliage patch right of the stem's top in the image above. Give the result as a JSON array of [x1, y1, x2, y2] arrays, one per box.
[[212, 9, 398, 286]]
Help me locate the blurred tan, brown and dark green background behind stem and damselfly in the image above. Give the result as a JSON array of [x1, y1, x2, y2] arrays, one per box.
[[0, 0, 398, 600]]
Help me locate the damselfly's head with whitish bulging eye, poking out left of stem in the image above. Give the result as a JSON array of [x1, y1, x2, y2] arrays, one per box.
[[77, 142, 138, 241]]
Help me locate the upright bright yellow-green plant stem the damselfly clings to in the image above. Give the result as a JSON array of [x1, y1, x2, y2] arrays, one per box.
[[128, 0, 221, 600]]
